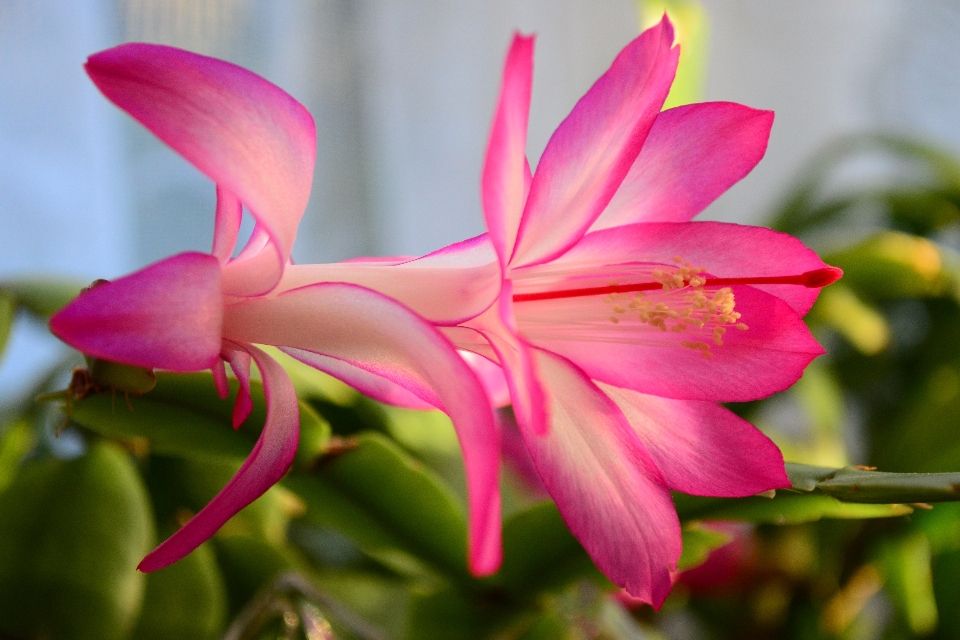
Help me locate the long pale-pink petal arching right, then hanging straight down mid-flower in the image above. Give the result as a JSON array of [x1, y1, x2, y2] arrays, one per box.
[[224, 284, 501, 575]]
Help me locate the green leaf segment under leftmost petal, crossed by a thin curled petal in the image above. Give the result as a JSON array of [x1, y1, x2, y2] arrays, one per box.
[[71, 372, 330, 466]]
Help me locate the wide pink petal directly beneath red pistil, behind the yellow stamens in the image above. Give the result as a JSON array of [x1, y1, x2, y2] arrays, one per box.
[[514, 286, 823, 402]]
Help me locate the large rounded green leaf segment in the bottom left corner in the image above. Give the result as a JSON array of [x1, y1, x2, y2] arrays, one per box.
[[0, 443, 153, 640]]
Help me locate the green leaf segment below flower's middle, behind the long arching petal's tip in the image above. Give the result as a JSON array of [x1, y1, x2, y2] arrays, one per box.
[[284, 433, 468, 578]]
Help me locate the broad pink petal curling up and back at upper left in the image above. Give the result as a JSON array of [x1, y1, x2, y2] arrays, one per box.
[[86, 43, 316, 295]]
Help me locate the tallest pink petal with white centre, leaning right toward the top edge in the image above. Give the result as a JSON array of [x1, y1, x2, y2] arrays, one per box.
[[509, 16, 680, 267]]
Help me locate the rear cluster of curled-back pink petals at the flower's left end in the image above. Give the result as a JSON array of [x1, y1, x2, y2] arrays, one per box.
[[50, 44, 500, 574]]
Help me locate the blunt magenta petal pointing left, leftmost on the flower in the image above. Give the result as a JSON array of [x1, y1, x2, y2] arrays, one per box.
[[50, 252, 223, 372]]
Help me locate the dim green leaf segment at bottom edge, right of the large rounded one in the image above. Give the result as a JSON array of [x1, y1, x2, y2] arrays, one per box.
[[130, 543, 227, 640]]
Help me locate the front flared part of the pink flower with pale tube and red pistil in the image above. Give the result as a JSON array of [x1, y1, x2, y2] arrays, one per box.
[[279, 18, 840, 606]]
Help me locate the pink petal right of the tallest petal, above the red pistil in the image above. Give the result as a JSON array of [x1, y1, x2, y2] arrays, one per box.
[[591, 102, 773, 231]]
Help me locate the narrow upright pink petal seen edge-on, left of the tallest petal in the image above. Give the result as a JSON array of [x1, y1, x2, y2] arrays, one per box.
[[482, 33, 534, 266]]
